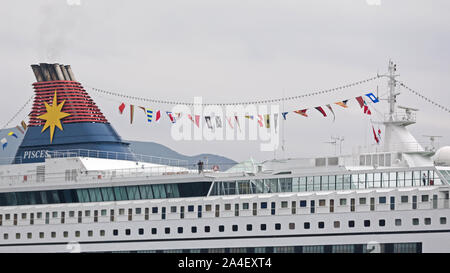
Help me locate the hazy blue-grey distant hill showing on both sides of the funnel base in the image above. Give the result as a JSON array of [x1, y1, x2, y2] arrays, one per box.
[[0, 128, 237, 170]]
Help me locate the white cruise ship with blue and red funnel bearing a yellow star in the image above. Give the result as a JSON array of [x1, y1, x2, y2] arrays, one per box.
[[0, 62, 450, 253]]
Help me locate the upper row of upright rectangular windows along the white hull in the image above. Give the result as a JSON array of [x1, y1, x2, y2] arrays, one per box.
[[0, 195, 442, 226]]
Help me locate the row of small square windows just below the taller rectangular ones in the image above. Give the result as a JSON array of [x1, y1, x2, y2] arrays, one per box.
[[3, 217, 447, 240]]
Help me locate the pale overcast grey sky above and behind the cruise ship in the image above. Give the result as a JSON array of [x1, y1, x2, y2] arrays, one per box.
[[0, 0, 450, 160]]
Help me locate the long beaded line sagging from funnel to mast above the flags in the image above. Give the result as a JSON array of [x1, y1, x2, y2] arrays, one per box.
[[86, 75, 382, 106]]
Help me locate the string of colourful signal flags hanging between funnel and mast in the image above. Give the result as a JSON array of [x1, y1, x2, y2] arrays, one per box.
[[114, 93, 379, 129]]
